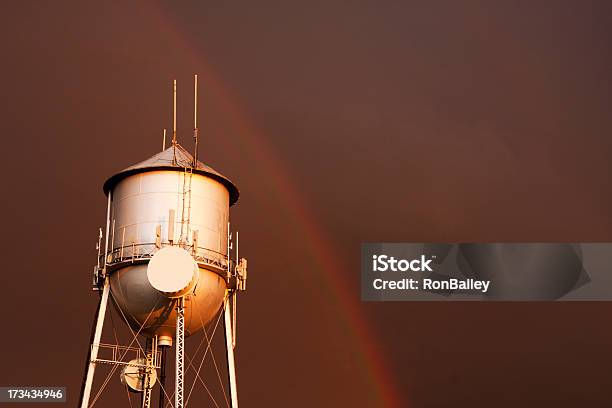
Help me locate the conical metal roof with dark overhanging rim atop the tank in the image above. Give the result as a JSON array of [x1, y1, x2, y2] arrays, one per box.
[[103, 143, 239, 205]]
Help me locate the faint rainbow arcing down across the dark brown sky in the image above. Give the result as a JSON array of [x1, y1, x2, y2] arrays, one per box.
[[145, 2, 405, 407]]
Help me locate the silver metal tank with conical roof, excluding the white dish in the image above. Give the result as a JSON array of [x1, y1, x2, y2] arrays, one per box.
[[104, 143, 238, 344]]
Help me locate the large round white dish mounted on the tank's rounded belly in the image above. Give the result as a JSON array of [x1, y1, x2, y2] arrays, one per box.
[[147, 246, 200, 298]]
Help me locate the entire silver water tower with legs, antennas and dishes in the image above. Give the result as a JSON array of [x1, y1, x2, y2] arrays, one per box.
[[80, 75, 247, 408]]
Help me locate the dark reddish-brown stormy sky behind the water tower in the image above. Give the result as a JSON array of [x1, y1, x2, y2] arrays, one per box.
[[0, 0, 612, 407]]
